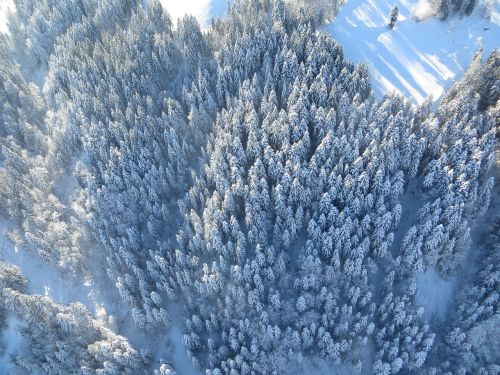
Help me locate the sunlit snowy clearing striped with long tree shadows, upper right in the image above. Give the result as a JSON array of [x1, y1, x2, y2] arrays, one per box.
[[326, 0, 500, 104]]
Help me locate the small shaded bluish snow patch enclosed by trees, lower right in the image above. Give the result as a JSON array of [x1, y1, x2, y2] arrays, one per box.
[[416, 268, 456, 320]]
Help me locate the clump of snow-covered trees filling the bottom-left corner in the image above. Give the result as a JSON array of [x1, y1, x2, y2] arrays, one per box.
[[0, 263, 148, 375]]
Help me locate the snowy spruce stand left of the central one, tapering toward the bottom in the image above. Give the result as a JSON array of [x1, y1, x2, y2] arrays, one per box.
[[38, 1, 216, 327]]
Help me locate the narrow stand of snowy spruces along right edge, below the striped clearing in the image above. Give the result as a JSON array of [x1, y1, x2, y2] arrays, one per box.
[[401, 53, 498, 274]]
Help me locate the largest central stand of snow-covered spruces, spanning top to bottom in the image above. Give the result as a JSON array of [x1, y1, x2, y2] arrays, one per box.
[[178, 1, 438, 374]]
